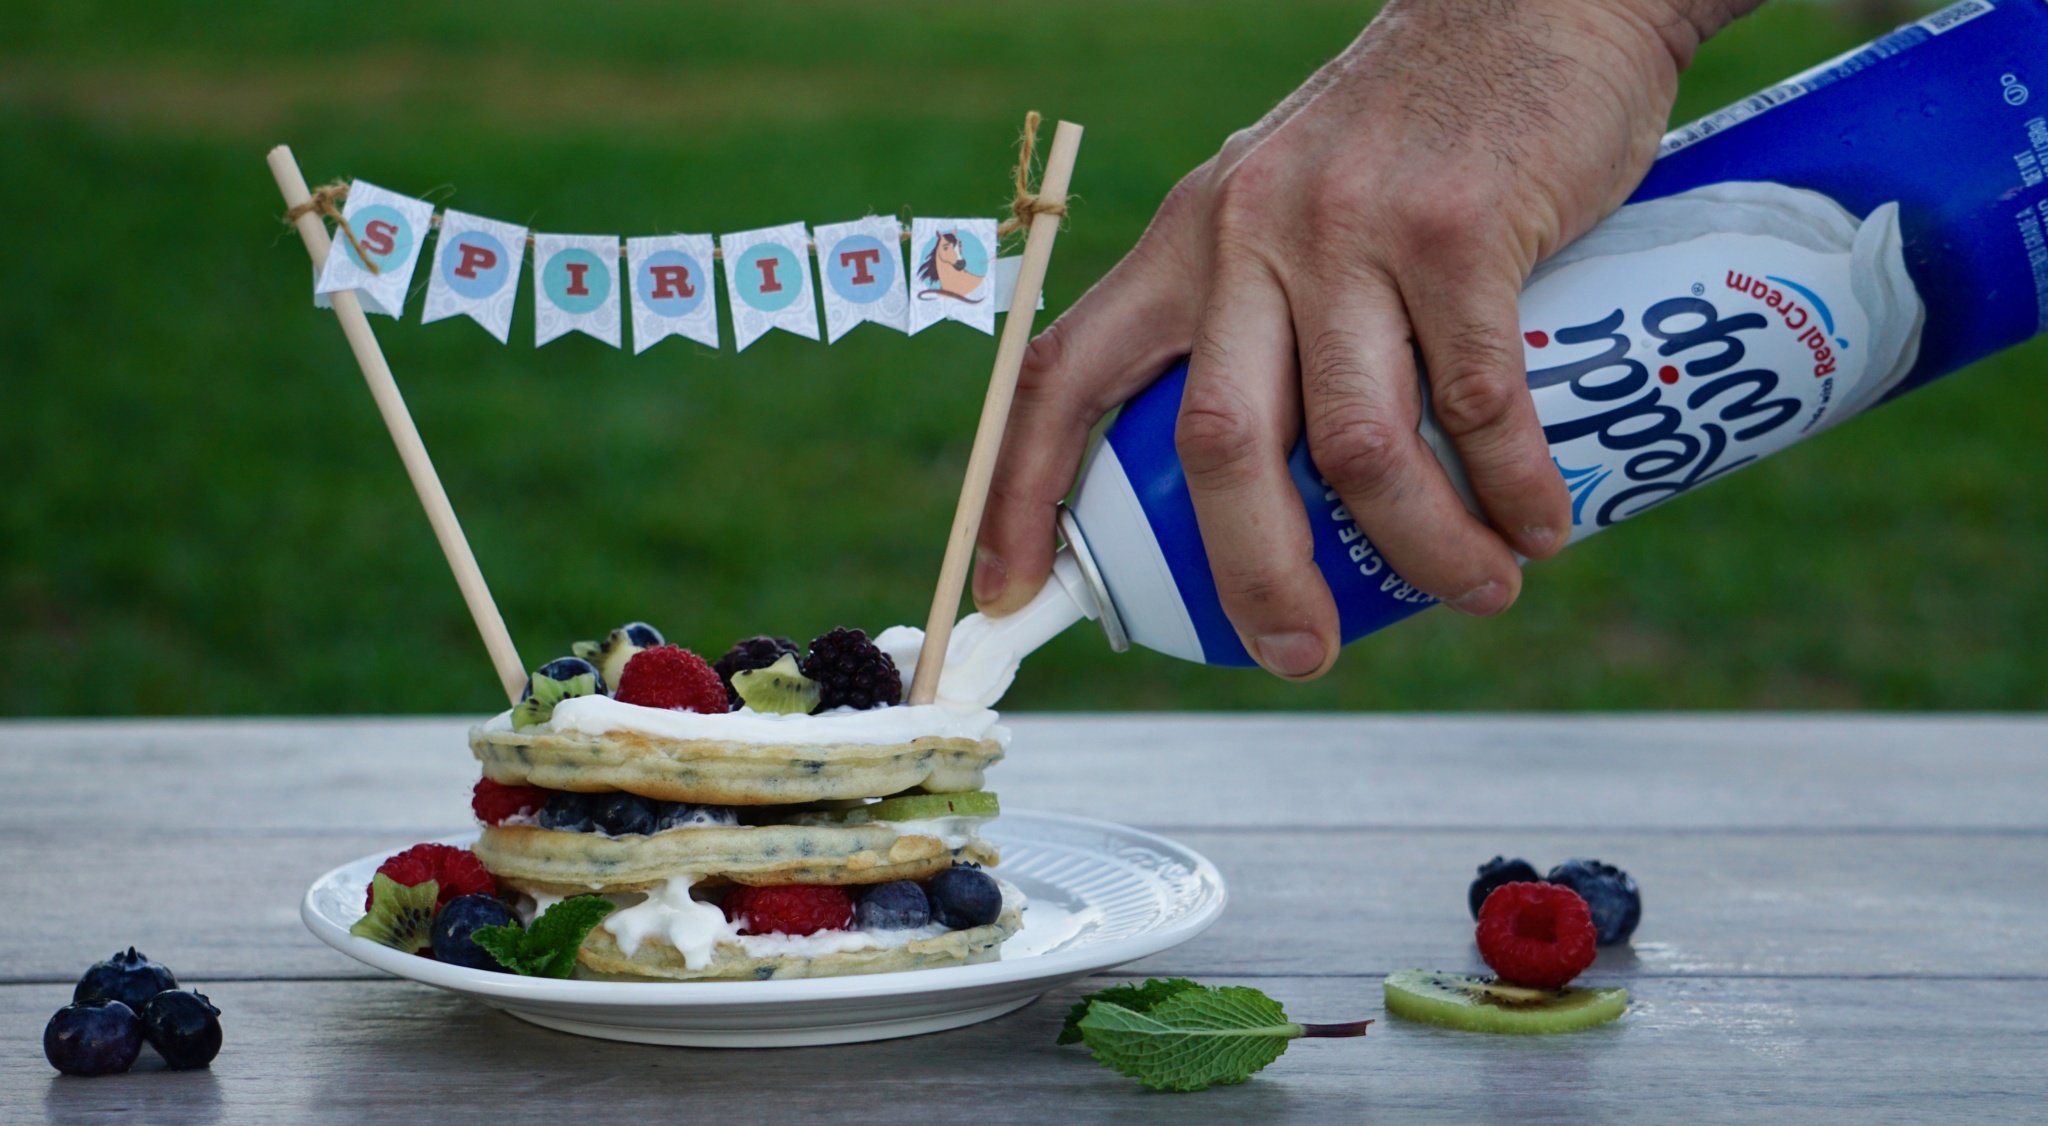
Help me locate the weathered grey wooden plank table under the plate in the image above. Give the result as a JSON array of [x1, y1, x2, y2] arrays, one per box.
[[0, 714, 2048, 1126]]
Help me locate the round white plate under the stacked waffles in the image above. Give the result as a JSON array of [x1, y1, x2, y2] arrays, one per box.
[[299, 811, 1225, 1048]]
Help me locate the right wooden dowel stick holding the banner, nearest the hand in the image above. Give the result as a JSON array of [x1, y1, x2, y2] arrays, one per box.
[[909, 121, 1081, 704]]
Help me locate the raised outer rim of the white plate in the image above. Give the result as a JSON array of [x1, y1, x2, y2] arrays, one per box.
[[299, 809, 1229, 1009]]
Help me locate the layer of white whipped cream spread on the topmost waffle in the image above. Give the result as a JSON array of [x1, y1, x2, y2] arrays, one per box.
[[495, 696, 1010, 747]]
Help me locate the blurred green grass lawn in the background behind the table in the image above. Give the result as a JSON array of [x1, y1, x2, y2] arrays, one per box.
[[0, 0, 2048, 714]]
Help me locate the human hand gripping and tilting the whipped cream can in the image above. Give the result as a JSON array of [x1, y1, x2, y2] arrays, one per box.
[[973, 0, 1759, 680]]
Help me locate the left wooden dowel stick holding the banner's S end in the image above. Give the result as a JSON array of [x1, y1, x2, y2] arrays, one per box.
[[268, 145, 526, 702]]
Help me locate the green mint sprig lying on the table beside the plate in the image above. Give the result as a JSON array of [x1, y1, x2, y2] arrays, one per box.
[[1057, 977, 1372, 1091]]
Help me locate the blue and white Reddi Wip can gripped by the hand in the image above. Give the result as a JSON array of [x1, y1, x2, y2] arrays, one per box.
[[1049, 0, 2048, 665]]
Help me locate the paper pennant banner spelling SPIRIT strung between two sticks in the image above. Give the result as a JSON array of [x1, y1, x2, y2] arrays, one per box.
[[313, 180, 1044, 354]]
